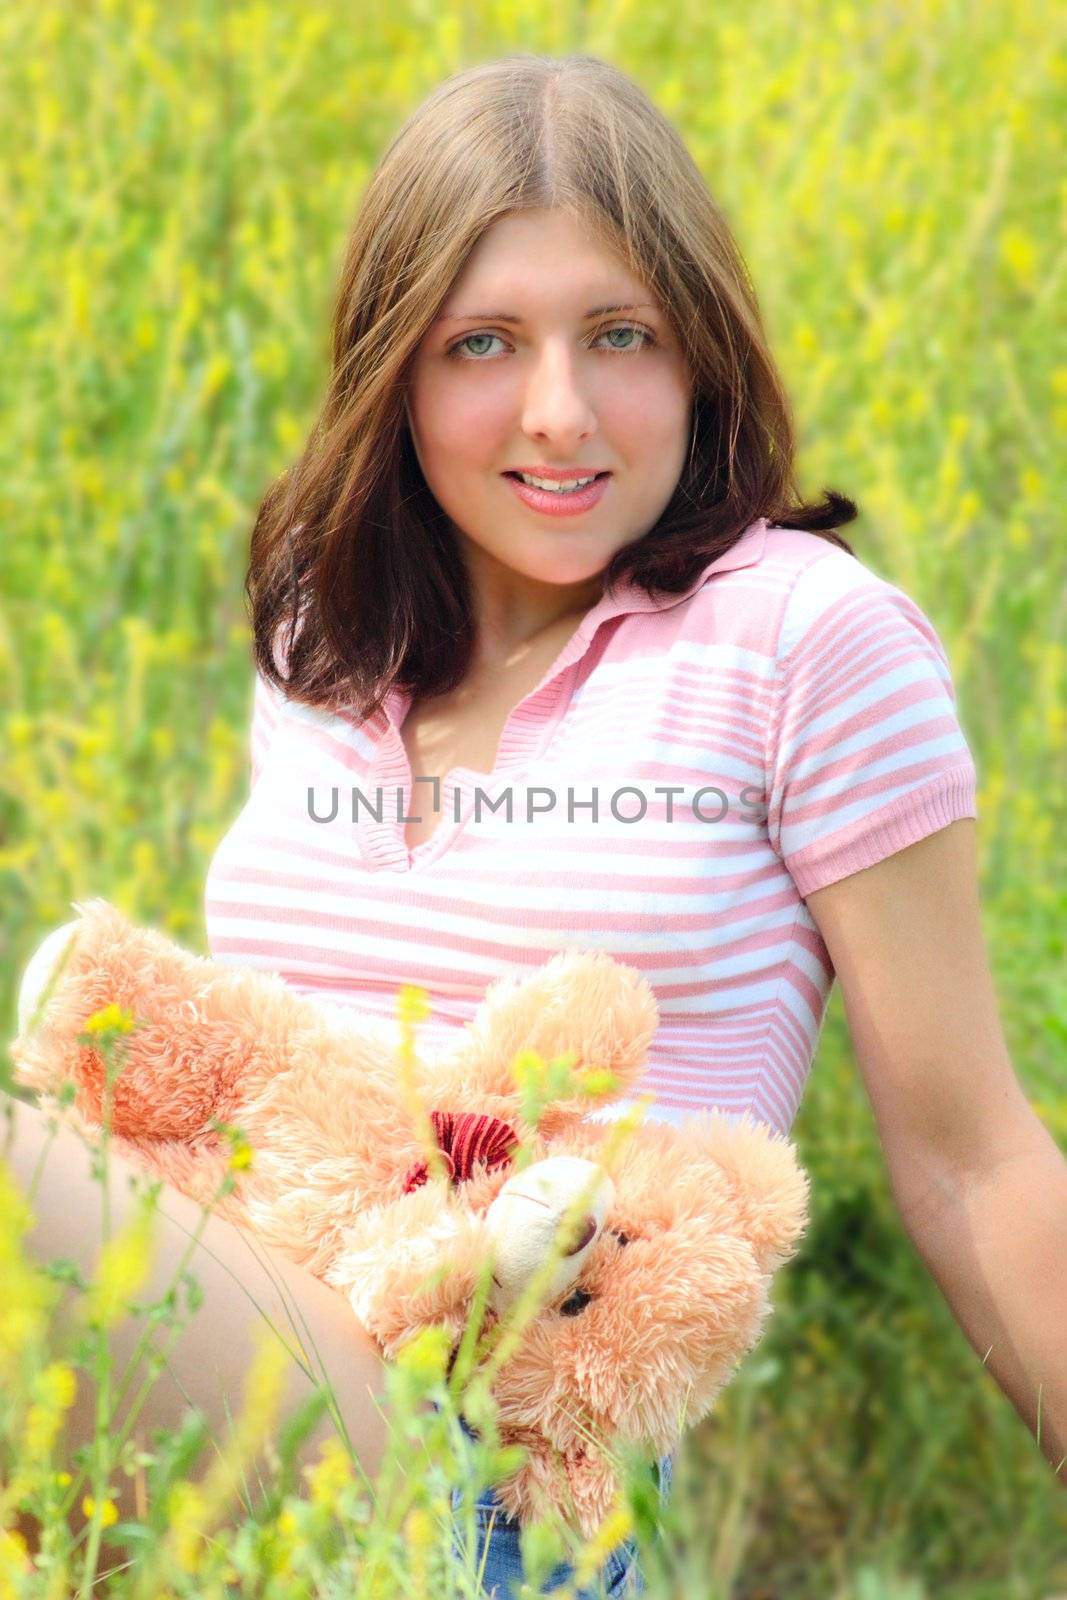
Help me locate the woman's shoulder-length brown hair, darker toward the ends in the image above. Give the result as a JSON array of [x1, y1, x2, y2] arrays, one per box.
[[245, 53, 857, 720]]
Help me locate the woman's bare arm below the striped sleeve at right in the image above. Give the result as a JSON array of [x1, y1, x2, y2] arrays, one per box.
[[806, 818, 1067, 1486]]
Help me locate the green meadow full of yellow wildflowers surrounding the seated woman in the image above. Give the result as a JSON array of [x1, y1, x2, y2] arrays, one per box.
[[0, 0, 1067, 1600]]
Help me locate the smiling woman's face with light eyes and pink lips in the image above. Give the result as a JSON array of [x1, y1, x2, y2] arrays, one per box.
[[408, 210, 691, 617]]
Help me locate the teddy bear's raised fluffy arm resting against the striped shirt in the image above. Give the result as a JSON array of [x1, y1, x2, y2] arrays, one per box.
[[435, 950, 659, 1136]]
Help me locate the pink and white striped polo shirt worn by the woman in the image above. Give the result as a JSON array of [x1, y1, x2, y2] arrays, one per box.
[[206, 518, 977, 1133]]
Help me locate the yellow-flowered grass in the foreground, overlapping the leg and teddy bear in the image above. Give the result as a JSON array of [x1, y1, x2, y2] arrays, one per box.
[[0, 1017, 668, 1600]]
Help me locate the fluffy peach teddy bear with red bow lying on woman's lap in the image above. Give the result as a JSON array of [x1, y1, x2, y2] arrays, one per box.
[[11, 899, 809, 1538]]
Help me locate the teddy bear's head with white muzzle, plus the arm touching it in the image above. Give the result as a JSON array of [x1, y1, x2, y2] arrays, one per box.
[[321, 1112, 808, 1534]]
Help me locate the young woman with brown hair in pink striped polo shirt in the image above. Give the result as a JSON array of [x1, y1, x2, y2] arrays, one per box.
[[12, 54, 1067, 1595]]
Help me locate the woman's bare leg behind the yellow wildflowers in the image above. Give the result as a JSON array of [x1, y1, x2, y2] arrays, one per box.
[[0, 1093, 395, 1555]]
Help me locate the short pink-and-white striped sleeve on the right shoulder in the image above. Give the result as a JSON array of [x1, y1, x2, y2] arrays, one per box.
[[766, 550, 977, 896]]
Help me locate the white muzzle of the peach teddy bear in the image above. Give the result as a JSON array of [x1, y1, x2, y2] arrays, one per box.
[[485, 1155, 614, 1315]]
